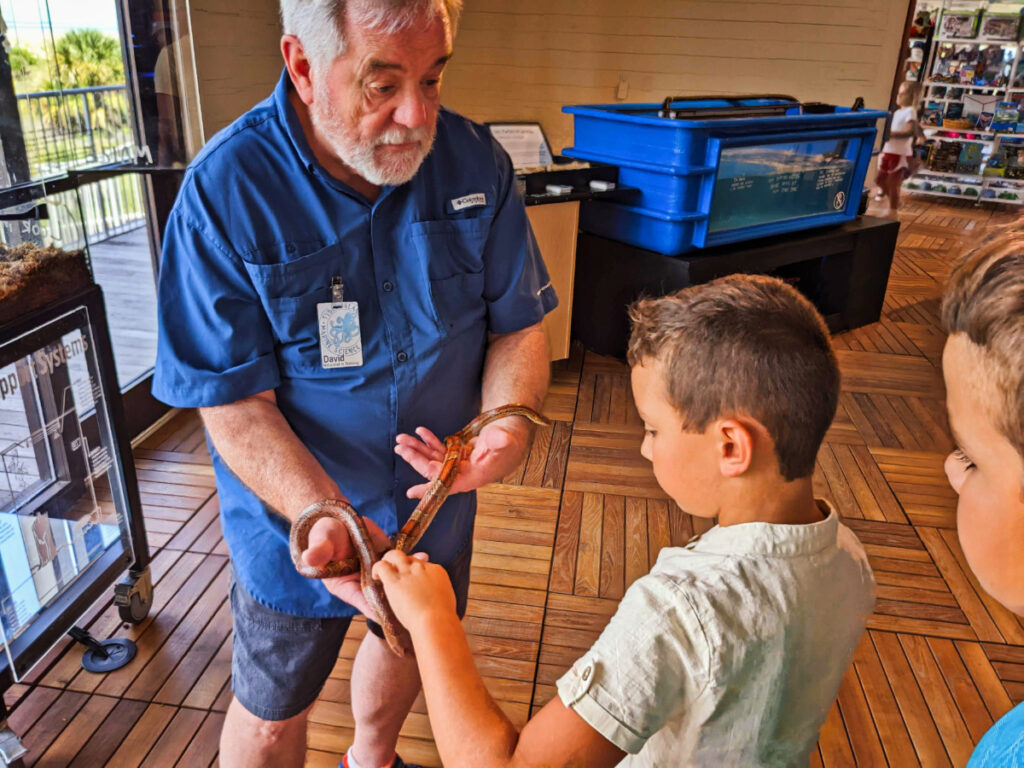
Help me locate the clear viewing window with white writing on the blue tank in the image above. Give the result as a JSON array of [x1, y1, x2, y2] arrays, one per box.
[[709, 138, 861, 232]]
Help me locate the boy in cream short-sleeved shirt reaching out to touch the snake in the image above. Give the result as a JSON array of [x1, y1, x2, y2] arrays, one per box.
[[375, 275, 874, 768]]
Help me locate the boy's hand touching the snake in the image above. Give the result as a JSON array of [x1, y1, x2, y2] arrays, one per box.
[[374, 550, 455, 636]]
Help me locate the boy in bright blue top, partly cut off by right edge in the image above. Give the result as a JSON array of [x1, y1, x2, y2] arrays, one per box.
[[942, 232, 1024, 768]]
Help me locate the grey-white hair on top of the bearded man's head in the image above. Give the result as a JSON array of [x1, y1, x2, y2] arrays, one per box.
[[281, 0, 462, 67]]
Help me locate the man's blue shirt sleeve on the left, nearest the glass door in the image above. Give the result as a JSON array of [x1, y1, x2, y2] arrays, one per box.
[[153, 177, 281, 408]]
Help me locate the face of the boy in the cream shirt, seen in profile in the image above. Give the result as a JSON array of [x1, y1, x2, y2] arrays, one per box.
[[630, 358, 721, 517]]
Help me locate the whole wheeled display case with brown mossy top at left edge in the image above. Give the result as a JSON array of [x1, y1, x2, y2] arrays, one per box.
[[0, 184, 152, 757]]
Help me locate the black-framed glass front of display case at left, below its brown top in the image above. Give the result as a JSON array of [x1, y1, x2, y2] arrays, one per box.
[[0, 286, 150, 687]]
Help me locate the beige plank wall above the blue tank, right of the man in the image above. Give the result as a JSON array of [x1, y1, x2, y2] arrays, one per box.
[[443, 0, 907, 152]]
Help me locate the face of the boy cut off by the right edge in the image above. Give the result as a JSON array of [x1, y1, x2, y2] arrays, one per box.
[[942, 334, 1024, 614]]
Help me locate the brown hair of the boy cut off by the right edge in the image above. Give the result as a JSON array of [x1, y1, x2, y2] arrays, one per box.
[[942, 230, 1024, 457]]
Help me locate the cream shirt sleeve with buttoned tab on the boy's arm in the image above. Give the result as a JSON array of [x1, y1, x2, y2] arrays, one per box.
[[557, 574, 711, 754]]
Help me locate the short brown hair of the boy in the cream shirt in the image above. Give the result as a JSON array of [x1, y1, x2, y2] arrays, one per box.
[[627, 274, 840, 480]]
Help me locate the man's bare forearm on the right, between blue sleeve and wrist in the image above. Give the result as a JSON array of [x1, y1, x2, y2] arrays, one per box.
[[481, 323, 551, 411]]
